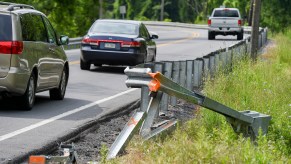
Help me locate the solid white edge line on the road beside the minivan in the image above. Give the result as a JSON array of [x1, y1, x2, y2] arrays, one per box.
[[0, 88, 137, 142]]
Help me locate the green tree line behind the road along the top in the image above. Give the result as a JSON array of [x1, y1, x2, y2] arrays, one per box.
[[4, 0, 291, 37]]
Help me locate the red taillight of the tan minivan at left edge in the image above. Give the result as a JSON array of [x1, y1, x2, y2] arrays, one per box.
[[0, 41, 23, 54]]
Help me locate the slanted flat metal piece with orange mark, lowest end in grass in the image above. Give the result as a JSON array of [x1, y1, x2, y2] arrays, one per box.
[[107, 112, 146, 159]]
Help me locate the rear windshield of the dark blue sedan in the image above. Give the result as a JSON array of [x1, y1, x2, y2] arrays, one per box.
[[90, 22, 138, 35]]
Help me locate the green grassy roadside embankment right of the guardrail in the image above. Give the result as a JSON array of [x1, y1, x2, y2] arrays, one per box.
[[111, 31, 291, 163]]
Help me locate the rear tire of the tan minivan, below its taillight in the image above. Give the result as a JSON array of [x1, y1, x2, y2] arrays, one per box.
[[19, 73, 36, 111]]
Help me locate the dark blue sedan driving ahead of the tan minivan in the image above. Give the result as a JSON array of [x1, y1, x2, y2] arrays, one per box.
[[80, 19, 158, 70]]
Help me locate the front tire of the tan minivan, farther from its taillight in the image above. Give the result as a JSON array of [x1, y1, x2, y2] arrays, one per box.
[[49, 67, 68, 100]]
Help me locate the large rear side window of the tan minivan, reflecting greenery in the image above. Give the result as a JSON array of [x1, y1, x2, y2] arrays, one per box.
[[20, 14, 48, 42]]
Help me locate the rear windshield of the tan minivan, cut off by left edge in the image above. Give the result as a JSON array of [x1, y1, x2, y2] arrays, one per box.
[[0, 15, 12, 41]]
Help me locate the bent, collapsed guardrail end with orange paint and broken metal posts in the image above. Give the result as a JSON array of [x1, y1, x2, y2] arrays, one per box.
[[107, 67, 271, 159]]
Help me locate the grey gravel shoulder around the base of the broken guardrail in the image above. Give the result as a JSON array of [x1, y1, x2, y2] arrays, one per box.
[[52, 100, 196, 163]]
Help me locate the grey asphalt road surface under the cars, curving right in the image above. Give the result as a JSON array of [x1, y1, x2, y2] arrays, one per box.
[[0, 26, 242, 163]]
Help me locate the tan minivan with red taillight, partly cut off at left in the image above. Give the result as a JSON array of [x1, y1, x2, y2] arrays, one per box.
[[0, 2, 69, 110]]
